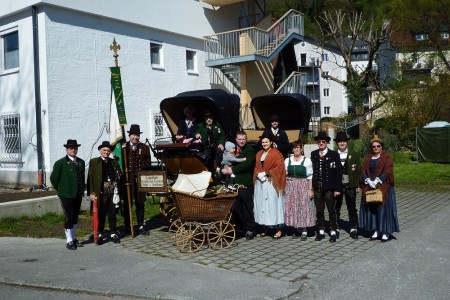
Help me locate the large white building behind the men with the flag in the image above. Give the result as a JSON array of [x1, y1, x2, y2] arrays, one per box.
[[0, 0, 250, 185]]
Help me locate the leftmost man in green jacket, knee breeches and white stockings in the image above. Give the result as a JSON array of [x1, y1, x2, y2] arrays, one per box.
[[50, 140, 85, 250]]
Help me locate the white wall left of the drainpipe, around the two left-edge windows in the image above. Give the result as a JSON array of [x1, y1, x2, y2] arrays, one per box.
[[0, 9, 37, 184]]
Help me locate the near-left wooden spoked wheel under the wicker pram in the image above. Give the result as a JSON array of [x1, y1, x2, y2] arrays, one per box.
[[175, 222, 205, 253]]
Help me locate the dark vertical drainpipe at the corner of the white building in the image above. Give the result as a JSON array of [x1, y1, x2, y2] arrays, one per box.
[[31, 6, 45, 188]]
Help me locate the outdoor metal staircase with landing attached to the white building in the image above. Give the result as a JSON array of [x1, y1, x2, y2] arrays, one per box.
[[205, 9, 304, 91]]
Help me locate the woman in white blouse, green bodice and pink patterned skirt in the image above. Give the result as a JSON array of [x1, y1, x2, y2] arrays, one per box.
[[284, 142, 316, 241]]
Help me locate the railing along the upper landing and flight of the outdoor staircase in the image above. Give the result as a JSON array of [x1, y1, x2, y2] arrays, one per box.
[[205, 9, 304, 61]]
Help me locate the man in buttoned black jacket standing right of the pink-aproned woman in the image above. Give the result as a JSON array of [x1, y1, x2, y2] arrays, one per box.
[[311, 131, 342, 243]]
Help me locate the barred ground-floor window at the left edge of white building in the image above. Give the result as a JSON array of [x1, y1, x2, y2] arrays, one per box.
[[0, 114, 22, 164]]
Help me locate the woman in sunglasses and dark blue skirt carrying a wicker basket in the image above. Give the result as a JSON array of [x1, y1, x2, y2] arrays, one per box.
[[359, 135, 400, 243]]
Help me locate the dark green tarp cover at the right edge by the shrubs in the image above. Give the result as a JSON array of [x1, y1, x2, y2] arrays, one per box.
[[416, 127, 450, 163]]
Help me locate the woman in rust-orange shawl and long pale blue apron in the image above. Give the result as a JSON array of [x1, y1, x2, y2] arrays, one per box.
[[253, 135, 286, 239]]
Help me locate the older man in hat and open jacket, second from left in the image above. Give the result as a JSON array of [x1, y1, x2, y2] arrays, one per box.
[[87, 141, 122, 245]]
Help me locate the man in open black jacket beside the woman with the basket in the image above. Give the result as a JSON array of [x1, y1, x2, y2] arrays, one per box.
[[334, 131, 361, 240]]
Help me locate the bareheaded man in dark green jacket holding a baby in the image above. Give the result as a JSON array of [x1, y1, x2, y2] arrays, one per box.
[[222, 131, 257, 240]]
